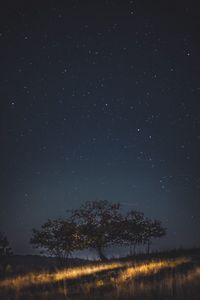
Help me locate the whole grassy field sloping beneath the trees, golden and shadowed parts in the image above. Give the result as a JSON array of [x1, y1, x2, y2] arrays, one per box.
[[0, 252, 200, 300]]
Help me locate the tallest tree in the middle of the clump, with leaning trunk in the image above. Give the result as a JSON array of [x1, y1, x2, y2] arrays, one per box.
[[72, 200, 122, 260]]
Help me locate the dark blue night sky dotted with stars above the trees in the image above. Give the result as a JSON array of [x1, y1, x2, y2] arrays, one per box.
[[0, 0, 200, 253]]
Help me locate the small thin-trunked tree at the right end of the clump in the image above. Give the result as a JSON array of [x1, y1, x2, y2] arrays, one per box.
[[143, 218, 166, 254]]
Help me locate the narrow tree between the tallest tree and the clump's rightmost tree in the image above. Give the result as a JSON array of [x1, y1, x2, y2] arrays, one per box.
[[122, 210, 144, 255]]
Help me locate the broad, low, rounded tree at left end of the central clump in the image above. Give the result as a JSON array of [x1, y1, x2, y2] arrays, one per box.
[[30, 219, 80, 262]]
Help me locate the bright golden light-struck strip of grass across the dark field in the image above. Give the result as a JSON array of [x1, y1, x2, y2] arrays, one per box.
[[0, 258, 189, 290]]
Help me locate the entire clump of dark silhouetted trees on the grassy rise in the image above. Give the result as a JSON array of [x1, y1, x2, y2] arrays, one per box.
[[31, 200, 166, 261]]
